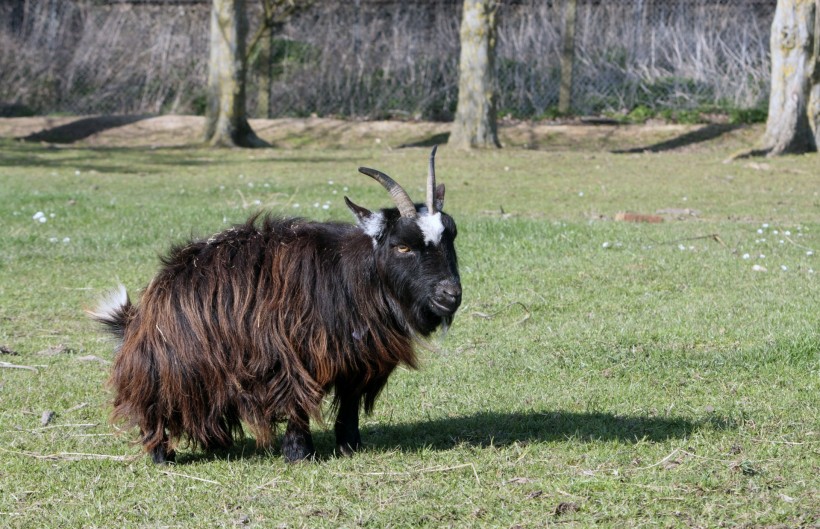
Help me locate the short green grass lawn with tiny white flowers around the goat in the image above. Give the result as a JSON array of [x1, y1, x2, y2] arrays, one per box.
[[0, 130, 820, 528]]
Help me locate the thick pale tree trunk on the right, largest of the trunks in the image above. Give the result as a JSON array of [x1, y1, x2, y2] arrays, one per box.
[[763, 0, 817, 156]]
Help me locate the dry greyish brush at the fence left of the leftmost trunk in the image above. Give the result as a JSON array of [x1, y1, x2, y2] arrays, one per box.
[[0, 0, 207, 114]]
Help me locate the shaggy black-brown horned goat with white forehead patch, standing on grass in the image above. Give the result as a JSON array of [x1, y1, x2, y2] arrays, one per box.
[[89, 148, 462, 464]]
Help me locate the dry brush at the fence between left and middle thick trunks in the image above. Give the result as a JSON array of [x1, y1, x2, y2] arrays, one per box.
[[272, 2, 459, 119]]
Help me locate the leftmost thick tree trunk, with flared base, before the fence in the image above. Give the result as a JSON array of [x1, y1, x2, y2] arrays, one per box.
[[205, 0, 268, 147]]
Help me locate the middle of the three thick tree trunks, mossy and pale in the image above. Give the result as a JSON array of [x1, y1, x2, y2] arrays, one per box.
[[449, 0, 501, 149]]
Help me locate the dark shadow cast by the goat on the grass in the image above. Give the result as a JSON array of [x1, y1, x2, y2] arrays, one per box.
[[171, 411, 704, 464]]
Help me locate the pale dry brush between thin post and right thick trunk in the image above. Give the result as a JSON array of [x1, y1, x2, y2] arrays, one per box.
[[575, 0, 770, 112]]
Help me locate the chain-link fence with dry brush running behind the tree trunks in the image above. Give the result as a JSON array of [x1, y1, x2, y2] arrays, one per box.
[[0, 0, 776, 120]]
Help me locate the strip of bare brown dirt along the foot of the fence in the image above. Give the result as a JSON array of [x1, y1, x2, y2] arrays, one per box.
[[0, 115, 761, 152]]
